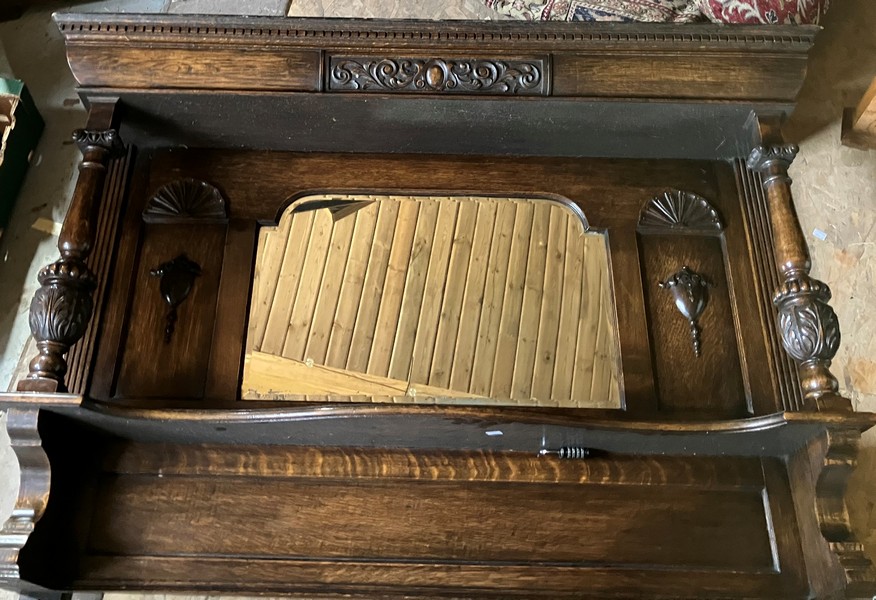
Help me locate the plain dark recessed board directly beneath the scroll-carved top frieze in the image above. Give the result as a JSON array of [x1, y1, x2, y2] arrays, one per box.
[[102, 88, 788, 160]]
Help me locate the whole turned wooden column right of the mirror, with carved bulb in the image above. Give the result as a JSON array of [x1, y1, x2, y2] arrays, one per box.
[[748, 144, 840, 408]]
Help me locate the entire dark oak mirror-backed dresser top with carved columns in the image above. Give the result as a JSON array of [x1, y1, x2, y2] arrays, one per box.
[[0, 14, 876, 599]]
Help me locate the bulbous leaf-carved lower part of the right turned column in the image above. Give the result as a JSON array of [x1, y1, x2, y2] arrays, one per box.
[[773, 273, 841, 402]]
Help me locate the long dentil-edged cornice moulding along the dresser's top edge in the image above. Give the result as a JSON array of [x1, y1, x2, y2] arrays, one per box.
[[55, 13, 819, 50]]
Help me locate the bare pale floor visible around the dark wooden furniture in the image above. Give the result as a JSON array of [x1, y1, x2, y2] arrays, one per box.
[[0, 0, 876, 598]]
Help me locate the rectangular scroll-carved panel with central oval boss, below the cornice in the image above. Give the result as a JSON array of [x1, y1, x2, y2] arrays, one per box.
[[326, 56, 549, 96]]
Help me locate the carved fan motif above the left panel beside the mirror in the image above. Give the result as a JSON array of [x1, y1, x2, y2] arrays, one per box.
[[143, 179, 226, 222]]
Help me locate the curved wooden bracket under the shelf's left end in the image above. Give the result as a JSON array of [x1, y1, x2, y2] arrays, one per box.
[[0, 407, 50, 589]]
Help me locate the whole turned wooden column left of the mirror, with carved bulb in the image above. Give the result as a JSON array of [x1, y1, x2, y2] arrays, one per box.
[[18, 122, 123, 392]]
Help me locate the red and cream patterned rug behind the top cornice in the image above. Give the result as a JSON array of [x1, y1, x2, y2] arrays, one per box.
[[483, 0, 830, 25]]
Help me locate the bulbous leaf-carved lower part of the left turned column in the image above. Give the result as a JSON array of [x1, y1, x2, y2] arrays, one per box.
[[18, 258, 96, 392]]
